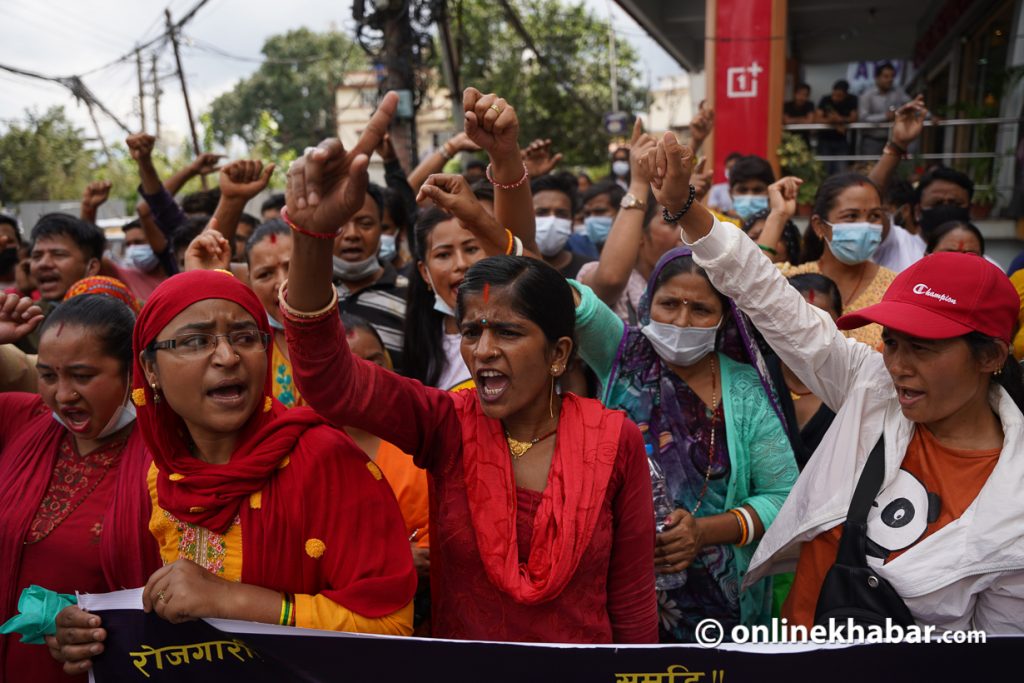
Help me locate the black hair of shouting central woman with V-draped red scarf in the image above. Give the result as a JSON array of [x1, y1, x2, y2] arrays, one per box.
[[456, 256, 575, 352]]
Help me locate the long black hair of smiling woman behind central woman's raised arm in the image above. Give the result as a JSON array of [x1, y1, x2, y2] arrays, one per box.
[[401, 208, 452, 389]]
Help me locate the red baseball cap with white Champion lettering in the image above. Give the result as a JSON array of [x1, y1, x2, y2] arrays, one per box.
[[836, 252, 1021, 344]]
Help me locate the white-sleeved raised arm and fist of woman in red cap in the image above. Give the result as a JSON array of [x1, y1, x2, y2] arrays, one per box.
[[641, 133, 882, 410]]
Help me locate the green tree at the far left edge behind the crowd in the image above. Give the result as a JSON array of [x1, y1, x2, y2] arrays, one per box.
[[0, 106, 95, 203]]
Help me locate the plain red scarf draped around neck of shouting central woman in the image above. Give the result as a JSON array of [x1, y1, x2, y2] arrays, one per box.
[[459, 394, 625, 605]]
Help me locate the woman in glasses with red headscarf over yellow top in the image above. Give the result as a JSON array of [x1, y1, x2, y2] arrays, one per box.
[[49, 270, 417, 673]]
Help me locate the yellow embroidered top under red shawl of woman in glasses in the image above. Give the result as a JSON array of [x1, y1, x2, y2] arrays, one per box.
[[147, 464, 413, 636]]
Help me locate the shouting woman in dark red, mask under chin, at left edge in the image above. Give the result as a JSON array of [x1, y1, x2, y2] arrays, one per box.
[[0, 294, 160, 683]]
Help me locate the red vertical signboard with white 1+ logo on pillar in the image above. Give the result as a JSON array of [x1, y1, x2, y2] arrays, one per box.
[[709, 0, 772, 181]]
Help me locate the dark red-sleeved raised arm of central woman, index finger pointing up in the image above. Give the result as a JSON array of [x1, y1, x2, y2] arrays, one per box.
[[281, 93, 461, 467]]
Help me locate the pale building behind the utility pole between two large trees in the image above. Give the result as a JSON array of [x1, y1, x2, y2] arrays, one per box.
[[334, 71, 457, 180]]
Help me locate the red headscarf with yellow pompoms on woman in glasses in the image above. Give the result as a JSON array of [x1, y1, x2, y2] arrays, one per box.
[[132, 270, 417, 617]]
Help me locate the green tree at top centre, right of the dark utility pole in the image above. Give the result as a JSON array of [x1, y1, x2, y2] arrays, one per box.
[[453, 0, 645, 165]]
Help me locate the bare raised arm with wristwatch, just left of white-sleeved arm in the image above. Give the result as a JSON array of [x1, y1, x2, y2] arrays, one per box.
[[581, 117, 657, 306]]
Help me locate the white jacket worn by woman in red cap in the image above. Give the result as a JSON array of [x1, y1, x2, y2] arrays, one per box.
[[691, 220, 1024, 634]]
